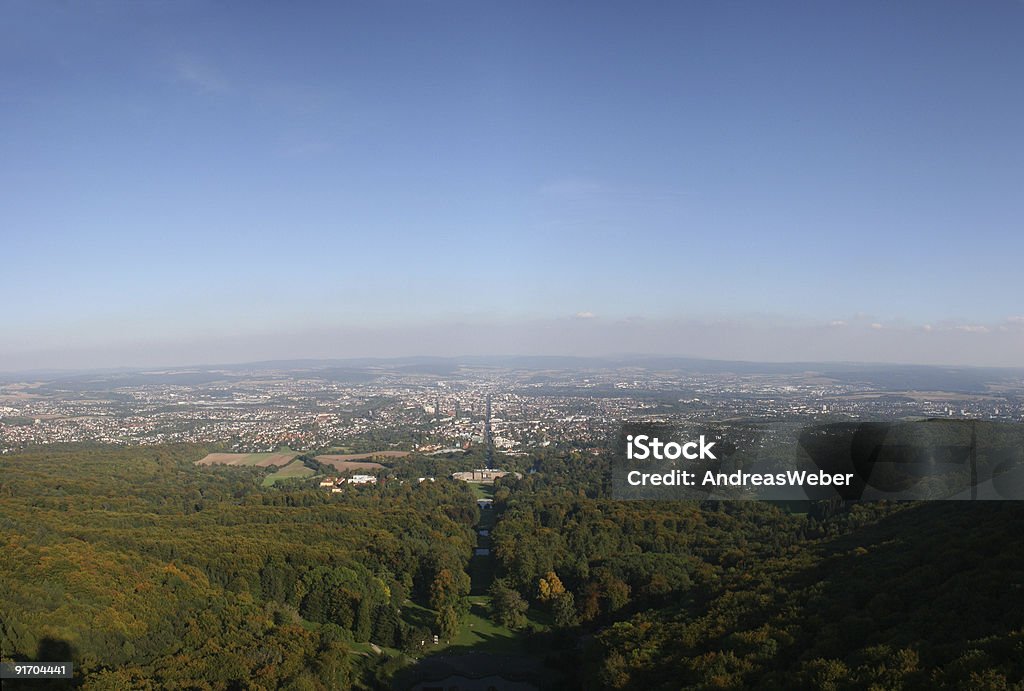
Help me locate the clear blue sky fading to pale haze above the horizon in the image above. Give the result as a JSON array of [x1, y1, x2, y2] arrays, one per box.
[[0, 0, 1024, 371]]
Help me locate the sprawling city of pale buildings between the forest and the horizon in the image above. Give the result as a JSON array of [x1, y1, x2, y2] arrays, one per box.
[[0, 366, 1024, 455]]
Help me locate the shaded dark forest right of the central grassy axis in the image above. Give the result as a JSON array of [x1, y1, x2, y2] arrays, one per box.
[[485, 454, 1024, 689]]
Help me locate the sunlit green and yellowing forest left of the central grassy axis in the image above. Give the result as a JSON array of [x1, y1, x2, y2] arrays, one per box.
[[0, 447, 478, 689]]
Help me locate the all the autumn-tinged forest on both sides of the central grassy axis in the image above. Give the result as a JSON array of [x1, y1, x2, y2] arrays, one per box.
[[0, 445, 1024, 689]]
